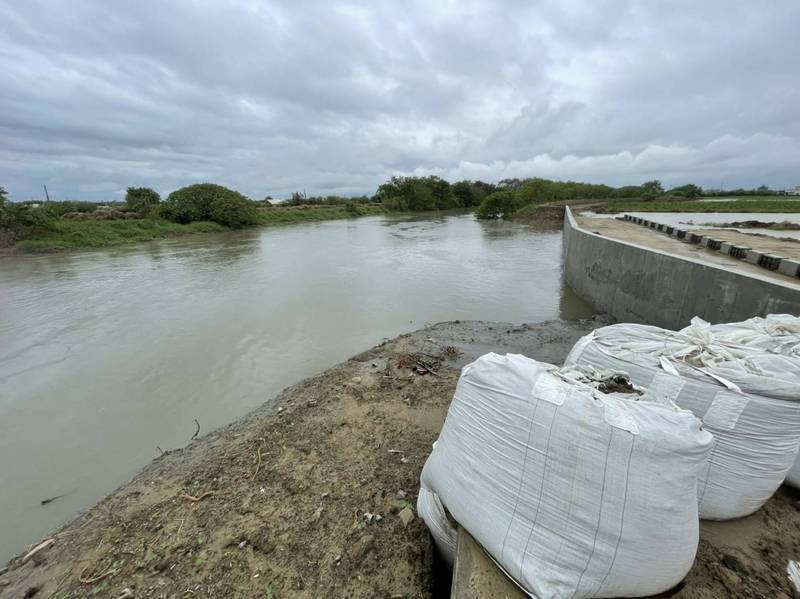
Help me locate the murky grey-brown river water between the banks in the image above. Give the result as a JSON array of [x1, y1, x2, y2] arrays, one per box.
[[0, 215, 591, 565]]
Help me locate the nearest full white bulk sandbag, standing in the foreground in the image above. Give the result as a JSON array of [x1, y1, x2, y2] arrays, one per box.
[[417, 354, 712, 599]]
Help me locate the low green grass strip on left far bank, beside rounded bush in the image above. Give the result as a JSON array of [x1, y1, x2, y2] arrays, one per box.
[[16, 219, 228, 252]]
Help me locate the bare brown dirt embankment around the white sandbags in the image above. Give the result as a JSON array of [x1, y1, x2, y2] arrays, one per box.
[[0, 321, 800, 599]]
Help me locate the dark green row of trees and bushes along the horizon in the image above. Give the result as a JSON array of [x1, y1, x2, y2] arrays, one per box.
[[0, 175, 780, 245]]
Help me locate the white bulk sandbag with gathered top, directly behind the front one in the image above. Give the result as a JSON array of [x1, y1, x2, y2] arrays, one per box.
[[566, 319, 800, 520]]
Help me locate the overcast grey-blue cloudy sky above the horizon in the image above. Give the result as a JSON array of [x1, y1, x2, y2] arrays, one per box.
[[0, 0, 800, 200]]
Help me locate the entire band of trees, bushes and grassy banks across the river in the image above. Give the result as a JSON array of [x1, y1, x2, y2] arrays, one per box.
[[0, 176, 800, 252]]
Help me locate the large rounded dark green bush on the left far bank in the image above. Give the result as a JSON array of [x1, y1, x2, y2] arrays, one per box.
[[161, 183, 257, 227]]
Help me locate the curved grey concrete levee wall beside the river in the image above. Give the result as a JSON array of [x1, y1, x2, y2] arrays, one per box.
[[564, 208, 800, 329]]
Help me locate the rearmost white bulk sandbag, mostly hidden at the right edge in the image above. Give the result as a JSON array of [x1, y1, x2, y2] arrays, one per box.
[[692, 314, 800, 488]]
